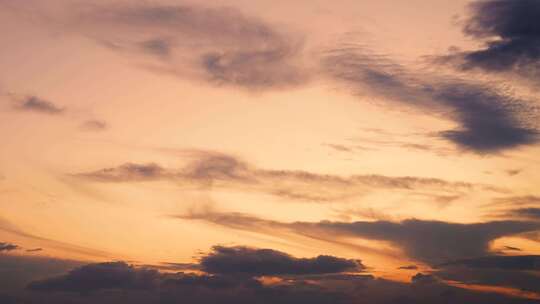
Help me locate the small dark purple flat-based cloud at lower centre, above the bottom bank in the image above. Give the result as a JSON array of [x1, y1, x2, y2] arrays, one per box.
[[200, 246, 365, 276]]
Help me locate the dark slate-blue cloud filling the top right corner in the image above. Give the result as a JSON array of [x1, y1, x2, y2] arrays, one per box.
[[452, 0, 540, 82]]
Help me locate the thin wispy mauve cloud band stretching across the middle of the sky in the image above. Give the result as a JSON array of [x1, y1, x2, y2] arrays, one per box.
[[73, 151, 498, 202]]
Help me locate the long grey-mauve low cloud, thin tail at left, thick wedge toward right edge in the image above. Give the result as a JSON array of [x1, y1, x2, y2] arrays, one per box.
[[178, 211, 540, 265]]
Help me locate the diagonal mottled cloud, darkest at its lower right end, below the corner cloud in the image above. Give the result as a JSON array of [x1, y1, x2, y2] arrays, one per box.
[[323, 47, 540, 153]]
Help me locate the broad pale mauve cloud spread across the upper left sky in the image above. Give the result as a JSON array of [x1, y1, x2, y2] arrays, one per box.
[[21, 1, 309, 90]]
